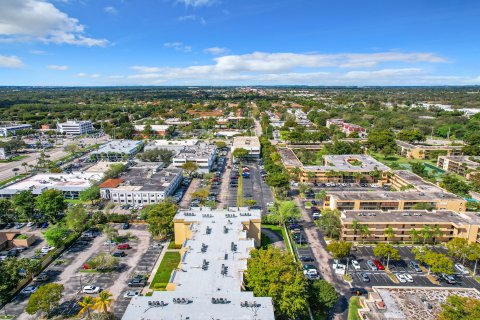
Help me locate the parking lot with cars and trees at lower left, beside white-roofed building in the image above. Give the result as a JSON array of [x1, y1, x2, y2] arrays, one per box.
[[6, 225, 161, 319]]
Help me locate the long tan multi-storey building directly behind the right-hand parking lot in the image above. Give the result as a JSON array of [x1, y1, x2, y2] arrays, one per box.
[[340, 210, 480, 243]]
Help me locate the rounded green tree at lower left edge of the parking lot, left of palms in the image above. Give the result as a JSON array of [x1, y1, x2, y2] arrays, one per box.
[[25, 283, 63, 318]]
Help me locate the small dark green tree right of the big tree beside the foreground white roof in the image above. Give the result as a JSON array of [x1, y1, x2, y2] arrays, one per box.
[[308, 280, 338, 319]]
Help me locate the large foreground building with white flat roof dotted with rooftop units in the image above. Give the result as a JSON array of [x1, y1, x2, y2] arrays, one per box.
[[122, 207, 275, 320]]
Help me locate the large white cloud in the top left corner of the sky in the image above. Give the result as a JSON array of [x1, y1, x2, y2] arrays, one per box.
[[0, 0, 108, 47]]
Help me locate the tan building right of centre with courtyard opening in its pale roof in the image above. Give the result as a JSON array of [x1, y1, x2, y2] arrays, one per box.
[[300, 154, 390, 184]]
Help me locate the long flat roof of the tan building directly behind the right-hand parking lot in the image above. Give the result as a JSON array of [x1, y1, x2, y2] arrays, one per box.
[[342, 210, 480, 226]]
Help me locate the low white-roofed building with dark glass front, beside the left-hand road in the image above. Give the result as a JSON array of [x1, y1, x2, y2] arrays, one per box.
[[90, 140, 143, 162]]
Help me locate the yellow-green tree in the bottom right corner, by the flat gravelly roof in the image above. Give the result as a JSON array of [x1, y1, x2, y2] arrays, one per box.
[[438, 295, 480, 320]]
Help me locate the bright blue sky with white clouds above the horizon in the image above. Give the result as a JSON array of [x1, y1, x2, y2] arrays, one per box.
[[0, 0, 480, 86]]
